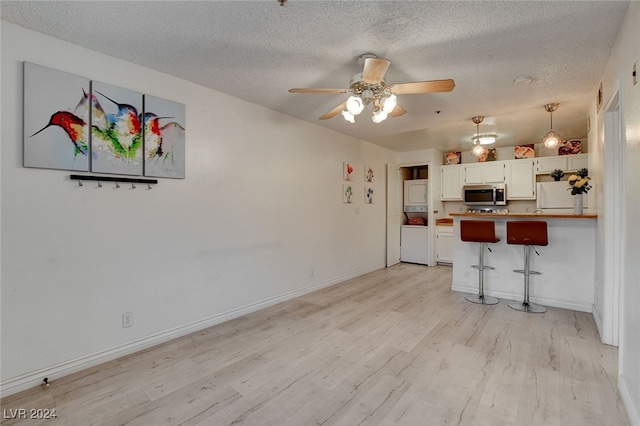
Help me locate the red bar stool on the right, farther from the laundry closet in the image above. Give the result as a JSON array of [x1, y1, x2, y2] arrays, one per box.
[[507, 220, 549, 314]]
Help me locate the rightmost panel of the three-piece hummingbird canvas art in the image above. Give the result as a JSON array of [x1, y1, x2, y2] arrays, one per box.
[[142, 95, 185, 179]]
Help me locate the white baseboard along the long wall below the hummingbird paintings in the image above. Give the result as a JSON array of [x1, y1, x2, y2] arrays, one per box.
[[0, 264, 385, 397]]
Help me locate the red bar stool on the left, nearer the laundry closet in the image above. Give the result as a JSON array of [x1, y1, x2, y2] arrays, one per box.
[[460, 220, 500, 305]]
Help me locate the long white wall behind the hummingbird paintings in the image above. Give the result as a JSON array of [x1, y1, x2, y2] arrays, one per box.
[[1, 22, 397, 394]]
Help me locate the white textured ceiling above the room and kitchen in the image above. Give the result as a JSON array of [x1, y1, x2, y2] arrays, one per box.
[[0, 0, 628, 151]]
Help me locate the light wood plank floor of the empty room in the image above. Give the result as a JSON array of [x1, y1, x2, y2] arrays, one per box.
[[2, 264, 629, 426]]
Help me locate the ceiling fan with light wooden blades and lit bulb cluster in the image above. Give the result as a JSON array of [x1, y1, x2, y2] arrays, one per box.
[[289, 53, 455, 123]]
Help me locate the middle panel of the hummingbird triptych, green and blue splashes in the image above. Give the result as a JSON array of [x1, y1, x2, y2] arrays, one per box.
[[91, 81, 143, 175]]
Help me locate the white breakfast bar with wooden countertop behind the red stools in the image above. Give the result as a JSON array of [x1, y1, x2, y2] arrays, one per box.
[[451, 213, 597, 312]]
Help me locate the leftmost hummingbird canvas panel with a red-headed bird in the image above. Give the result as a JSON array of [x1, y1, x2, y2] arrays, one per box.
[[23, 62, 90, 172]]
